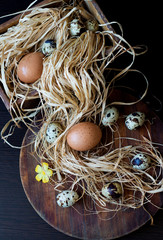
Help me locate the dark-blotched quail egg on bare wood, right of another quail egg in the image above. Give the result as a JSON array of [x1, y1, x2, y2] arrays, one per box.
[[125, 112, 145, 130]]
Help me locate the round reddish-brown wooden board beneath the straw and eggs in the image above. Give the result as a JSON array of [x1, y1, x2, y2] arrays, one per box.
[[20, 91, 163, 240]]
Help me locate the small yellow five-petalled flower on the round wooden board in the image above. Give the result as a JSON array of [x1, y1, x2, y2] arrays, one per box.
[[35, 162, 53, 183]]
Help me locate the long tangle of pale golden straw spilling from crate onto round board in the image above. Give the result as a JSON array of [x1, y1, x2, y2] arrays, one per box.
[[0, 0, 163, 214]]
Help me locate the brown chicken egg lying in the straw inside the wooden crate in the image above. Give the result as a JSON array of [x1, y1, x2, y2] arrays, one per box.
[[17, 52, 44, 83]]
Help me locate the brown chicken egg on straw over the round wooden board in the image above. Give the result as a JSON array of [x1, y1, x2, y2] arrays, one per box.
[[67, 122, 102, 151]]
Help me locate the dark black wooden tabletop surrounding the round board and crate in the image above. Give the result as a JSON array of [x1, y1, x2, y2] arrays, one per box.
[[0, 0, 163, 240]]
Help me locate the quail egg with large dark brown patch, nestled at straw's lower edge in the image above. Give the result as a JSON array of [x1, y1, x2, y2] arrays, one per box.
[[102, 182, 122, 200]]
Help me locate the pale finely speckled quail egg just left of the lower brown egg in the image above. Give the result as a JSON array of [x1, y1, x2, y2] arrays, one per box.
[[46, 122, 63, 143]]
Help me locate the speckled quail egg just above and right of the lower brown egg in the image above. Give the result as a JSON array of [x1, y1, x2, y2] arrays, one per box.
[[102, 106, 119, 126]]
